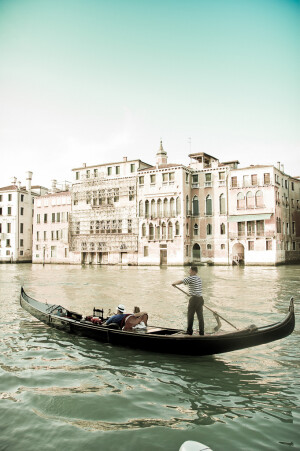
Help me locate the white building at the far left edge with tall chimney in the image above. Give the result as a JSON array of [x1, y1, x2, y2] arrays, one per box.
[[0, 172, 47, 263]]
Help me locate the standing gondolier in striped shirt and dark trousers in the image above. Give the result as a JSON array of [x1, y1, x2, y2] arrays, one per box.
[[172, 266, 204, 335]]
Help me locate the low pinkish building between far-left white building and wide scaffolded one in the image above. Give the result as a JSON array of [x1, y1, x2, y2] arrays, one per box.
[[32, 181, 71, 263]]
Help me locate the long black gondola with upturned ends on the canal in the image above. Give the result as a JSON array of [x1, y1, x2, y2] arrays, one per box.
[[20, 287, 295, 356]]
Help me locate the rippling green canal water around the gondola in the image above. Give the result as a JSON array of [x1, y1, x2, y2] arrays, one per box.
[[0, 264, 300, 451]]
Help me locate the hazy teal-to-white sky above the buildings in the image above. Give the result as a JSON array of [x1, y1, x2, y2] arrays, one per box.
[[0, 0, 300, 186]]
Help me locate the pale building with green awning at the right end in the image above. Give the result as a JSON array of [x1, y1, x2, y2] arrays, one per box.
[[228, 163, 300, 265]]
